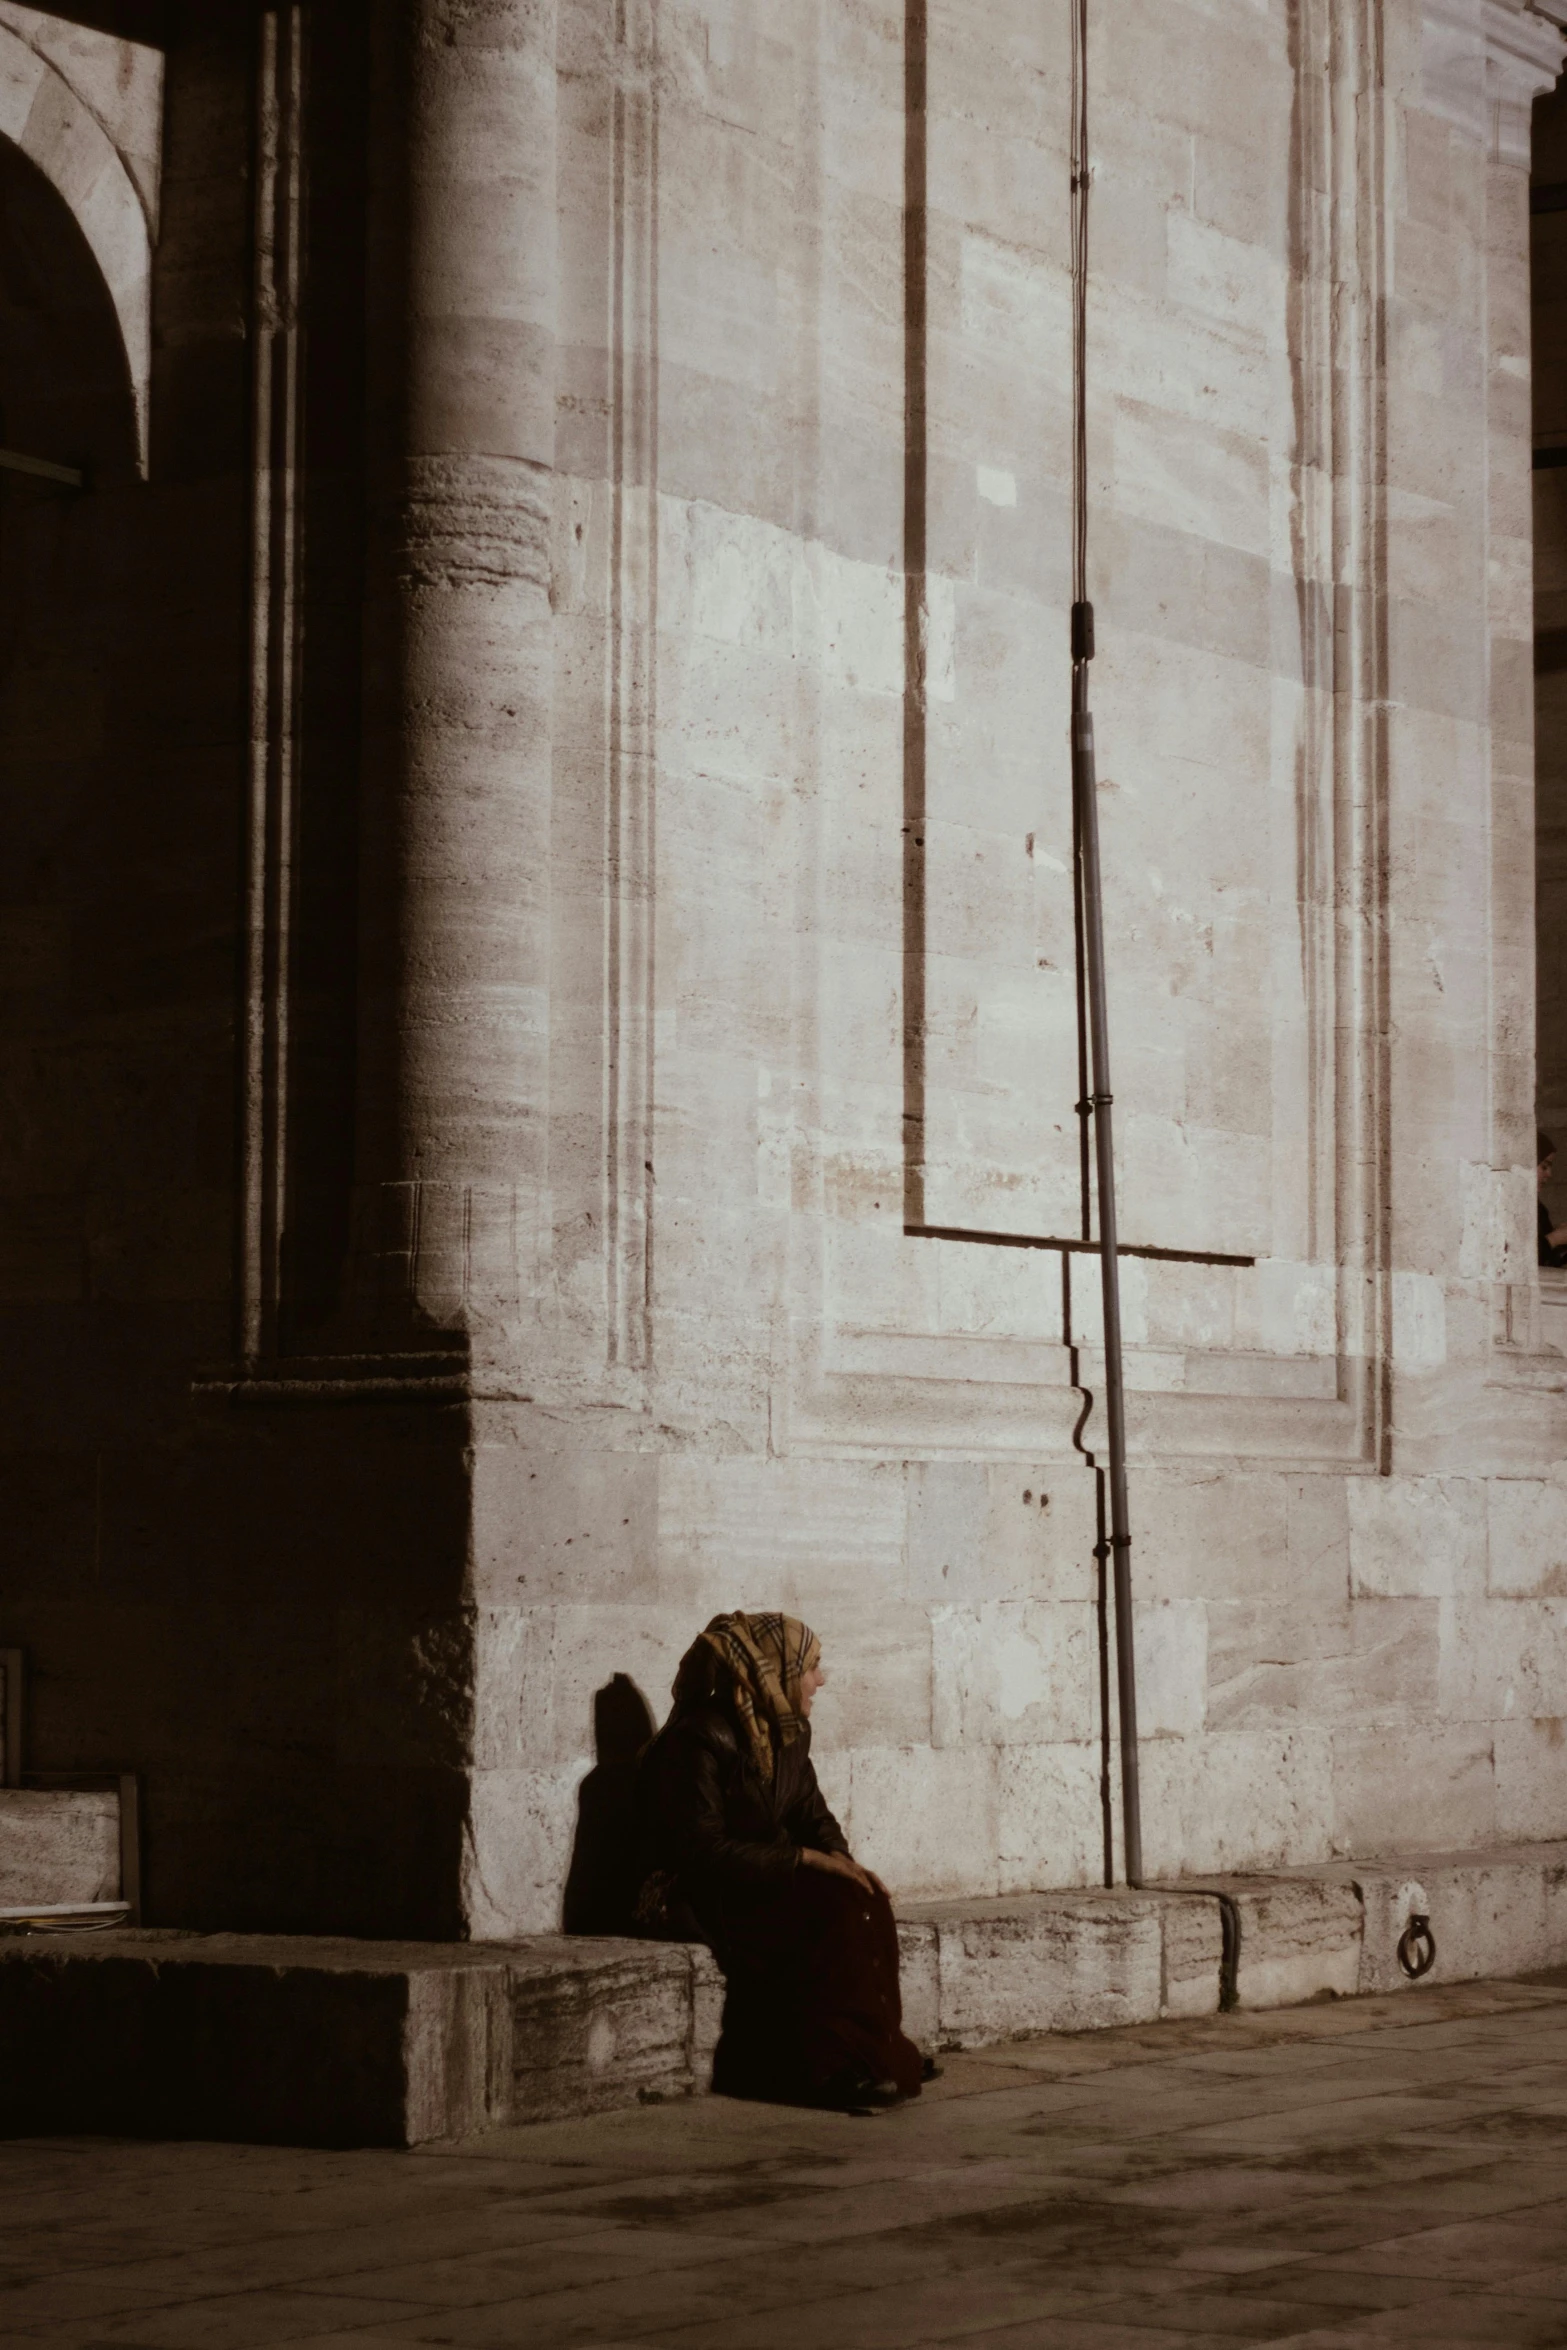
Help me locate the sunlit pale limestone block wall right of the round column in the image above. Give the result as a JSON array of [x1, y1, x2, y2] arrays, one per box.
[[468, 0, 1567, 1929]]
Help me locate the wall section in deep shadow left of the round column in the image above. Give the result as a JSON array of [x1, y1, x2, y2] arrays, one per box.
[[0, 0, 470, 1934]]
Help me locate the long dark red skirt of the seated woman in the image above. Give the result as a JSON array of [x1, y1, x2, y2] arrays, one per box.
[[712, 1868, 921, 2106]]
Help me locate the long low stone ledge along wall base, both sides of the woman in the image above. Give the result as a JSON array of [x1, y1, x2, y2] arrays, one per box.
[[0, 1845, 1567, 2146]]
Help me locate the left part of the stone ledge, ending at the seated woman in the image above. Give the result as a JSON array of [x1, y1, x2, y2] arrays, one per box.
[[0, 1932, 721, 2146]]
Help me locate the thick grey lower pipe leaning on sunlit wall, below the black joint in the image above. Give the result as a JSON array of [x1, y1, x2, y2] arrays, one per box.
[[1071, 648, 1142, 1885]]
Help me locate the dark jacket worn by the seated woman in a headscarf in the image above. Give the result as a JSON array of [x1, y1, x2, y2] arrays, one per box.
[[639, 1699, 848, 1955]]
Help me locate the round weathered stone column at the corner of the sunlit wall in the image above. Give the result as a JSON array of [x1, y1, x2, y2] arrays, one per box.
[[352, 0, 557, 1344]]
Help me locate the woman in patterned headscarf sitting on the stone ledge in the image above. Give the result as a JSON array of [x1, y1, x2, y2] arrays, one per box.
[[637, 1614, 928, 2108]]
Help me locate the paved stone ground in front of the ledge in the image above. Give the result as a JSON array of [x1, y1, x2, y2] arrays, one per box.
[[0, 1972, 1567, 2350]]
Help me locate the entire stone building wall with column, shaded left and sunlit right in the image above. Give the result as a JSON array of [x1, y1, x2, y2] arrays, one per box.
[[0, 0, 1567, 1934]]
